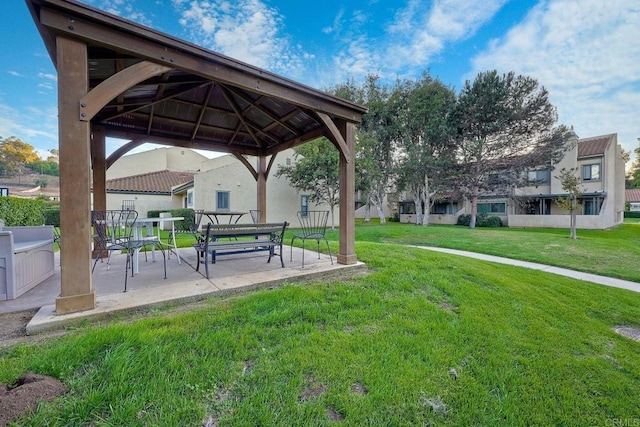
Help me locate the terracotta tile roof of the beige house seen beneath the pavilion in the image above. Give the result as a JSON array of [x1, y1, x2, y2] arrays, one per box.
[[106, 170, 194, 194]]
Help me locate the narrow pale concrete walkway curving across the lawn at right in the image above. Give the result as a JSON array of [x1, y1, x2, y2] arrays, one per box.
[[414, 246, 640, 292]]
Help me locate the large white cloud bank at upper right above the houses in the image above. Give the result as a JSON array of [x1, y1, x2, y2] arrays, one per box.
[[466, 0, 640, 154]]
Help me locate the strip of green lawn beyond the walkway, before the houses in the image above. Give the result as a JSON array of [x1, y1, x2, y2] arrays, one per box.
[[348, 223, 640, 282]]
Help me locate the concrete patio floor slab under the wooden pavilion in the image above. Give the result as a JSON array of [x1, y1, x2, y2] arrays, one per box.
[[0, 246, 364, 335]]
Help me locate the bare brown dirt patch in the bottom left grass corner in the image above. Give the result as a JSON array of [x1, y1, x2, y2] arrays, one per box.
[[0, 373, 67, 426]]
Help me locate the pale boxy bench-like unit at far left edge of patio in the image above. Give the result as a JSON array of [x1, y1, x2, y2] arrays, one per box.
[[0, 220, 54, 301]]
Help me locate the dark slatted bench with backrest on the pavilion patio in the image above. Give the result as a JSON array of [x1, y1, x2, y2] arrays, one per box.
[[193, 222, 289, 279]]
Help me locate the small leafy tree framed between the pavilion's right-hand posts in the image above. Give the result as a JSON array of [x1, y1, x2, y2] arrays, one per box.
[[276, 138, 340, 229]]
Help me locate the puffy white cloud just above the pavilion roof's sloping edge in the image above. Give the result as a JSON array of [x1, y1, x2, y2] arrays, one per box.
[[174, 0, 307, 75]]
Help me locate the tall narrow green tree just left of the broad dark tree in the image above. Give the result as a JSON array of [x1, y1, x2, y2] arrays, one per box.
[[395, 74, 455, 225]]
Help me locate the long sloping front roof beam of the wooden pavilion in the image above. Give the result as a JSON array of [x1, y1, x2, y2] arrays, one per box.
[[40, 4, 366, 123]]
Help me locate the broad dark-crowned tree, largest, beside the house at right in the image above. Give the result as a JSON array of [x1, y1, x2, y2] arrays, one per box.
[[451, 71, 570, 228]]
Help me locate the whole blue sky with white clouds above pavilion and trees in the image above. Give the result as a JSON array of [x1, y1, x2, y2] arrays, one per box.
[[0, 0, 640, 160]]
